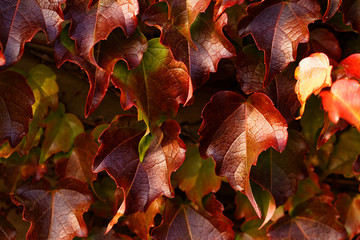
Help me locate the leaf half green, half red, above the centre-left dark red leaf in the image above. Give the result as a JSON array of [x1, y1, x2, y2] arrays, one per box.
[[112, 39, 192, 129]]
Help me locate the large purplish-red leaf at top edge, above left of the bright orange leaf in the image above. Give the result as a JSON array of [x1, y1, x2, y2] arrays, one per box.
[[238, 0, 321, 86]]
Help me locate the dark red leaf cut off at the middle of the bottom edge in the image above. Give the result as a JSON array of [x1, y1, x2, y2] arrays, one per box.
[[152, 195, 234, 240]]
